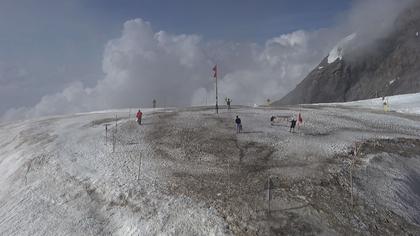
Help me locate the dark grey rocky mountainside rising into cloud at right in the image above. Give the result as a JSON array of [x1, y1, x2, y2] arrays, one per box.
[[274, 1, 420, 105]]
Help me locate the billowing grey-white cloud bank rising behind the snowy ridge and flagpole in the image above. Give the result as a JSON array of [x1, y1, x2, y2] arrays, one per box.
[[3, 0, 410, 120]]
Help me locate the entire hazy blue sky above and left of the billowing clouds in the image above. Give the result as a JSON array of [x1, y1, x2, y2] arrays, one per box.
[[0, 0, 364, 117]]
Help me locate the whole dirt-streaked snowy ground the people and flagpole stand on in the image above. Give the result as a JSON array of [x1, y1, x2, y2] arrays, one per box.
[[0, 106, 420, 235]]
